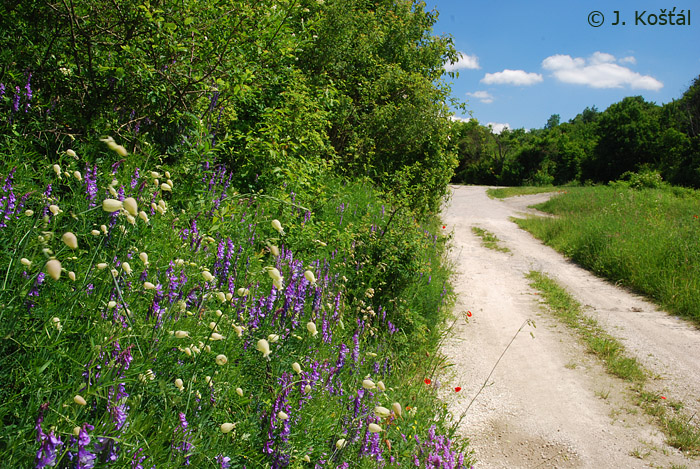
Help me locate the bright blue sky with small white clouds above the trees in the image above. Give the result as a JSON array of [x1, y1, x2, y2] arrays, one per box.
[[426, 0, 700, 129]]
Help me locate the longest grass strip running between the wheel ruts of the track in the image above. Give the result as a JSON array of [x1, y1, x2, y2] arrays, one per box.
[[527, 271, 700, 455]]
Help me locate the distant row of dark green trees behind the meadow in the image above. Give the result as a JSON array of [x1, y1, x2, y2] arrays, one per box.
[[451, 76, 700, 188]]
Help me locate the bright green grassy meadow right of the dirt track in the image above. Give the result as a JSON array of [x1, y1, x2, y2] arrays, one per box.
[[516, 186, 700, 324]]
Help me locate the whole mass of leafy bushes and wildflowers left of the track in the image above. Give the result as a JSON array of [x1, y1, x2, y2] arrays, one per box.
[[0, 0, 470, 468]]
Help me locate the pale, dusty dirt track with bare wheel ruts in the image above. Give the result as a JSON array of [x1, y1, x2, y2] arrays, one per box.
[[442, 186, 700, 469]]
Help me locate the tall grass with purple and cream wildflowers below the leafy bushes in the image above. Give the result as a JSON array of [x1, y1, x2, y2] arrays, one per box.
[[0, 141, 469, 468]]
